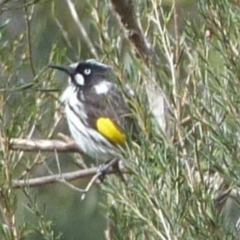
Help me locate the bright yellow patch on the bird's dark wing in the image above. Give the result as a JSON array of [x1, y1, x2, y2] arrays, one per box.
[[96, 117, 126, 145]]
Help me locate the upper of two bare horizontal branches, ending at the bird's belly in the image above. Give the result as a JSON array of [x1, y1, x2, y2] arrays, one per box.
[[3, 138, 81, 153]]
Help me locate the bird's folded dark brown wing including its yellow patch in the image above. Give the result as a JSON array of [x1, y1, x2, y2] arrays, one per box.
[[84, 86, 132, 145]]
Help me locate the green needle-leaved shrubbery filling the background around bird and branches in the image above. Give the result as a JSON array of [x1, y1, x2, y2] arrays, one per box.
[[0, 0, 240, 240]]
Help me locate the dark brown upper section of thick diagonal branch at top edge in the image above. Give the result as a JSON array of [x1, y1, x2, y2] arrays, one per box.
[[111, 0, 154, 61]]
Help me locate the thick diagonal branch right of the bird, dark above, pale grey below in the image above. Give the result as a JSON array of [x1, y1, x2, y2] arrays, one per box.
[[111, 0, 172, 138]]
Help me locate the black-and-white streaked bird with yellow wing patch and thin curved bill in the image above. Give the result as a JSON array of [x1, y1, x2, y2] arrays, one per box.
[[49, 59, 134, 162]]
